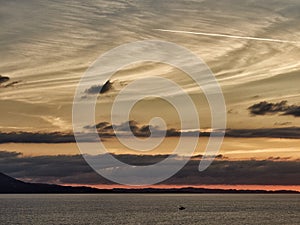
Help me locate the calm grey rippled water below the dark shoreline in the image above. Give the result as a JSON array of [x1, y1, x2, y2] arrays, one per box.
[[0, 194, 300, 225]]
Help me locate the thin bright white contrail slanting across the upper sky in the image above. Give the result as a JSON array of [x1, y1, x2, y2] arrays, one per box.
[[153, 29, 299, 44]]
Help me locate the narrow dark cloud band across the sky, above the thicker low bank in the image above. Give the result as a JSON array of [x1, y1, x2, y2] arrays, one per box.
[[0, 121, 300, 143]]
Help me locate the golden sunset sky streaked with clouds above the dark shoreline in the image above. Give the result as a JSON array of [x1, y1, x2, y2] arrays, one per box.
[[0, 0, 300, 190]]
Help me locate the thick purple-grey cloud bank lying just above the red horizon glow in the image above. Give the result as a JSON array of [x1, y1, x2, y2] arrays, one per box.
[[0, 152, 300, 185]]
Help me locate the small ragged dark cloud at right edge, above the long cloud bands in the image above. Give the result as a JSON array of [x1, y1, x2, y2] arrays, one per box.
[[248, 101, 300, 117]]
